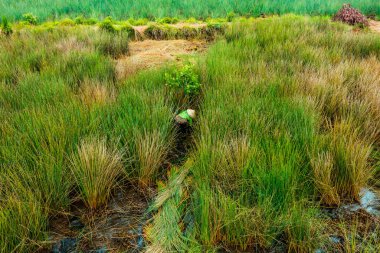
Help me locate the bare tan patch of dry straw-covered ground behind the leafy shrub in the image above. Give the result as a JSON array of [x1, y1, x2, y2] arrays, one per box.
[[116, 40, 207, 79]]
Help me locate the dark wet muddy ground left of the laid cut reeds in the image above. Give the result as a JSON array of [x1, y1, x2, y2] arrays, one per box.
[[41, 185, 153, 253]]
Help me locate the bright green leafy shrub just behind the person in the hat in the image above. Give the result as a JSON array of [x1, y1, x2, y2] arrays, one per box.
[[165, 65, 201, 96]]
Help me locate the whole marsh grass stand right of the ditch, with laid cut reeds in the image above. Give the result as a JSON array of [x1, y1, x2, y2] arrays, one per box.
[[147, 15, 380, 252]]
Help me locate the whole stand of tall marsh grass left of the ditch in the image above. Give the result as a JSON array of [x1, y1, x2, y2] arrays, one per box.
[[0, 26, 177, 252]]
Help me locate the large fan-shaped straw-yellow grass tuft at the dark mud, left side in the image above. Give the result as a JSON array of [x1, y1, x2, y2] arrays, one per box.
[[71, 139, 123, 209]]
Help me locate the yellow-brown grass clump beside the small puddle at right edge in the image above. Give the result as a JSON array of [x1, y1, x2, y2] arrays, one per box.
[[311, 122, 373, 206]]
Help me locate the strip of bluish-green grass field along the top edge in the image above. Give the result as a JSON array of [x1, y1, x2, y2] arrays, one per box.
[[0, 0, 380, 20]]
